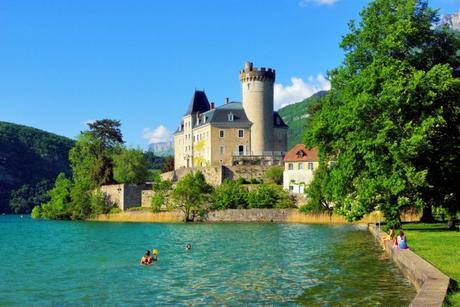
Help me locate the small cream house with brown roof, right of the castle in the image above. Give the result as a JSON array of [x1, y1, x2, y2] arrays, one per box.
[[283, 144, 319, 194]]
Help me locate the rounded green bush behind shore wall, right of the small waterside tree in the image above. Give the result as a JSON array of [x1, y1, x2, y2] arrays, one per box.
[[211, 180, 248, 210]]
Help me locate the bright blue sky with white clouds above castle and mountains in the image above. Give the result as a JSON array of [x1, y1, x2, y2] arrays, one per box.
[[0, 0, 460, 148]]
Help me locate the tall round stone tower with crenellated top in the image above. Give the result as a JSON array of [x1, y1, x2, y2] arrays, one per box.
[[240, 62, 275, 155]]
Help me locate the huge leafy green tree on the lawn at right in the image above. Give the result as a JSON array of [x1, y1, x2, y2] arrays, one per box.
[[306, 0, 460, 223]]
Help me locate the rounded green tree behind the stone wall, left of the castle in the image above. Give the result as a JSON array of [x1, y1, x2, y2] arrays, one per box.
[[113, 149, 149, 184]]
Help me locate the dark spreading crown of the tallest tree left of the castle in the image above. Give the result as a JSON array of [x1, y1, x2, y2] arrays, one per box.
[[88, 119, 124, 149]]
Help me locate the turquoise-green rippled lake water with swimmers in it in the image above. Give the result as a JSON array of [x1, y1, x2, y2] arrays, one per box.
[[0, 216, 415, 306]]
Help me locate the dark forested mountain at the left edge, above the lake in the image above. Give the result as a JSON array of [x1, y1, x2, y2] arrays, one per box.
[[0, 121, 75, 213]]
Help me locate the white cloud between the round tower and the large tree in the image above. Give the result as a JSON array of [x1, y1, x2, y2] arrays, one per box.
[[274, 74, 331, 110]]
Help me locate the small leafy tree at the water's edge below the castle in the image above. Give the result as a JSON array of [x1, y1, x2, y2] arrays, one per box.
[[171, 172, 212, 222]]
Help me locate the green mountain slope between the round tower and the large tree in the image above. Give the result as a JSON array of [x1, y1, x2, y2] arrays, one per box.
[[278, 91, 327, 148]]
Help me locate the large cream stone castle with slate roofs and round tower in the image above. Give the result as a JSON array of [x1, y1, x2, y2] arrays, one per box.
[[174, 62, 288, 169]]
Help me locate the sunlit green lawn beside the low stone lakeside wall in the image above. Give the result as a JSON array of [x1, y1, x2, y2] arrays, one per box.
[[403, 223, 460, 306]]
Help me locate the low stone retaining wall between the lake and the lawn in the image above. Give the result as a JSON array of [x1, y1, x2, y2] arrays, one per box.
[[369, 224, 450, 307]]
